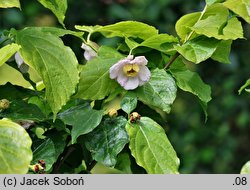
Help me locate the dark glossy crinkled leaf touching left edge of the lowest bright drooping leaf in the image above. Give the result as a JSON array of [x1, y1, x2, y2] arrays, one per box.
[[85, 117, 128, 167]]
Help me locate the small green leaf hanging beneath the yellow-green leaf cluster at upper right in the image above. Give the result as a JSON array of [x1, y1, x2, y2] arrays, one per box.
[[211, 40, 232, 63]]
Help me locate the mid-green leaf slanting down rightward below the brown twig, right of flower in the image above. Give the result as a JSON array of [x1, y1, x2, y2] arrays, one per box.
[[170, 60, 211, 103]]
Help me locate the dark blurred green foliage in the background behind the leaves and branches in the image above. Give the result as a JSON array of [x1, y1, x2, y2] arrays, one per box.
[[0, 0, 250, 173]]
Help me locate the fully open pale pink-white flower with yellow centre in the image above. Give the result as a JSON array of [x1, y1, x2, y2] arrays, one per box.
[[109, 55, 151, 90]]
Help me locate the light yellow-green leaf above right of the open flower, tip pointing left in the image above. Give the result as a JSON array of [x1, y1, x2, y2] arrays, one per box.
[[137, 34, 178, 53]]
